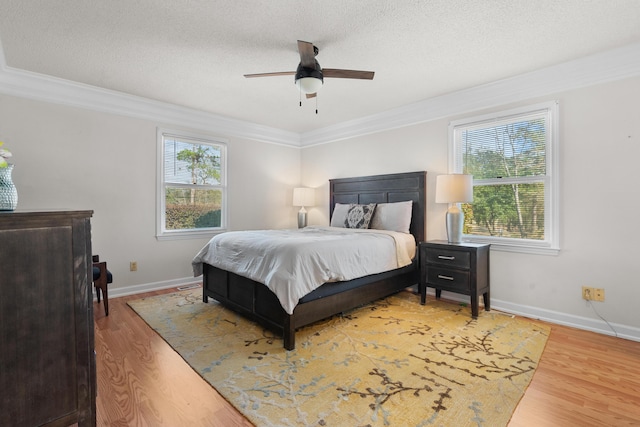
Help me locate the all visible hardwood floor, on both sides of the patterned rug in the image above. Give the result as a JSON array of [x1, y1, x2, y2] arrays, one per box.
[[94, 290, 640, 427]]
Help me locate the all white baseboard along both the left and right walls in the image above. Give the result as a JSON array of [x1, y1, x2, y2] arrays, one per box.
[[101, 277, 640, 342]]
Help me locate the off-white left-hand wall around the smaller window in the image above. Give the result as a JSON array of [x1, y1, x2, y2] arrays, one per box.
[[0, 95, 300, 296]]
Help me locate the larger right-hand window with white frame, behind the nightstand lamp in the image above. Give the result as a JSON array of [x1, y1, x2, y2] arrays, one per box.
[[449, 102, 559, 254]]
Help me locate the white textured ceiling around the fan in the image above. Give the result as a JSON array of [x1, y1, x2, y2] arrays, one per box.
[[0, 0, 640, 133]]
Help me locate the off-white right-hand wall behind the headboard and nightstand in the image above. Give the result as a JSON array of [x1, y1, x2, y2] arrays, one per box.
[[302, 77, 640, 339]]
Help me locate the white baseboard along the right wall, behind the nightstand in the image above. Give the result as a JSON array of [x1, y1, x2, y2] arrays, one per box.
[[427, 290, 640, 342]]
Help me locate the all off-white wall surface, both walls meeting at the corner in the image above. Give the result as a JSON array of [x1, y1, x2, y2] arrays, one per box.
[[0, 71, 640, 340]]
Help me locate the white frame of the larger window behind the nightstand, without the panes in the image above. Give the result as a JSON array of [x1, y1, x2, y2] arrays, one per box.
[[448, 101, 560, 255]]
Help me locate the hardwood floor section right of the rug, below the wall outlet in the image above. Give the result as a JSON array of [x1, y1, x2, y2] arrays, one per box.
[[509, 322, 640, 427]]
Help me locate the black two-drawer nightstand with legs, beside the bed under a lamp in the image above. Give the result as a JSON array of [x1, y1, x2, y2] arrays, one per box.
[[418, 240, 491, 318]]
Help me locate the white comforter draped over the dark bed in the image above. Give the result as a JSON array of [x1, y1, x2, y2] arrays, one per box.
[[192, 226, 416, 314]]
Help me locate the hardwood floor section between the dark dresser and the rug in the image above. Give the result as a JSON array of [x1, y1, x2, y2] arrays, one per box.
[[94, 291, 253, 427]]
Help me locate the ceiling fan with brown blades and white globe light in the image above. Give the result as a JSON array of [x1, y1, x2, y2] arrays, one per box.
[[244, 40, 374, 107]]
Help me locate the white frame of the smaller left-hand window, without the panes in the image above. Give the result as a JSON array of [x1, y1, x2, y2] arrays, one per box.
[[156, 128, 229, 240]]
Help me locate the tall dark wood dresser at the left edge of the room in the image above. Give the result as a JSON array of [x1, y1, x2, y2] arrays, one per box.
[[0, 211, 96, 426]]
